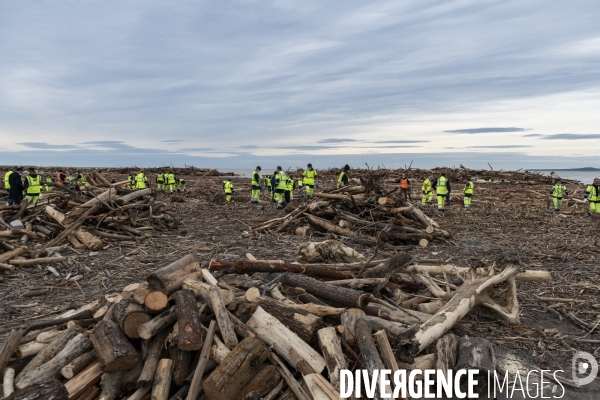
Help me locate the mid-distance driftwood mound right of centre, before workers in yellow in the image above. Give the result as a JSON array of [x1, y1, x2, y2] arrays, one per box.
[[244, 185, 451, 249]]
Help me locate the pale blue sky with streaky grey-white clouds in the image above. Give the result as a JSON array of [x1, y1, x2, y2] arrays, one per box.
[[0, 0, 600, 169]]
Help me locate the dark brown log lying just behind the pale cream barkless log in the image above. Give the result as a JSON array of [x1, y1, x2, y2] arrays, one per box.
[[253, 296, 323, 344]]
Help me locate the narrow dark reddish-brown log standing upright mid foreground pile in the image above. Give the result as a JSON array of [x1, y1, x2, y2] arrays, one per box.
[[174, 289, 204, 351]]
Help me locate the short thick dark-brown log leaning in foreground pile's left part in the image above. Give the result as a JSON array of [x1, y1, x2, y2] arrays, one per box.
[[91, 320, 140, 372]]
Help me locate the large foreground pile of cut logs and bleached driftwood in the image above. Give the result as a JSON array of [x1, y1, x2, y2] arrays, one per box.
[[0, 253, 550, 400]]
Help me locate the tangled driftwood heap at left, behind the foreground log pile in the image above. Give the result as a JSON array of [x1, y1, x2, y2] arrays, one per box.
[[0, 171, 176, 270]]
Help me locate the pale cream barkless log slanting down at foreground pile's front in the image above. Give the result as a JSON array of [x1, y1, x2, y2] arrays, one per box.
[[246, 307, 327, 375]]
